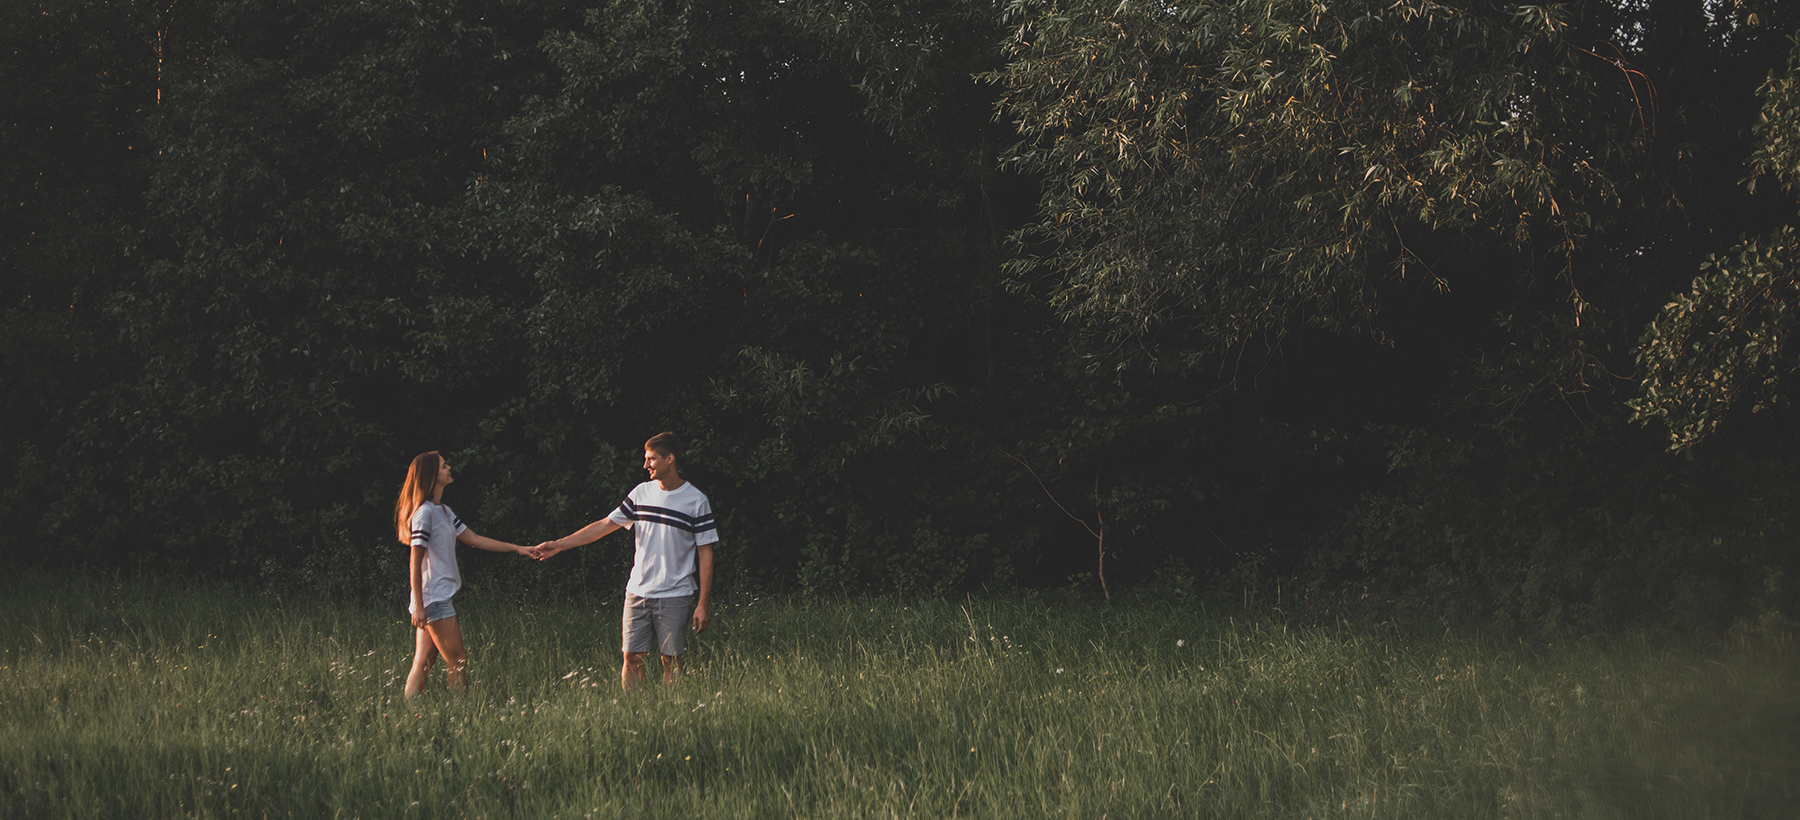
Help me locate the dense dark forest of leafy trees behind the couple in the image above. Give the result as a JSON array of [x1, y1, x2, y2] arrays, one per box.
[[0, 0, 1800, 631]]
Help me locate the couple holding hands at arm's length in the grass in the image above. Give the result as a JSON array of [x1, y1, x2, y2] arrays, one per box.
[[394, 433, 718, 698]]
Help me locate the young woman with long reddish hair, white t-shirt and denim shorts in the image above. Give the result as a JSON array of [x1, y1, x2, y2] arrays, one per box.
[[394, 450, 527, 698]]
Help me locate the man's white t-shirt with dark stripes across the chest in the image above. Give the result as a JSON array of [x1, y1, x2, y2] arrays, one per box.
[[607, 482, 718, 597]]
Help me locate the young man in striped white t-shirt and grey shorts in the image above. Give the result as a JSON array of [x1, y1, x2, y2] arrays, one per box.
[[533, 433, 718, 691]]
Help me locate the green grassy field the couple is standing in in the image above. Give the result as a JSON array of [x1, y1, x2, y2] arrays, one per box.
[[0, 577, 1800, 818]]
